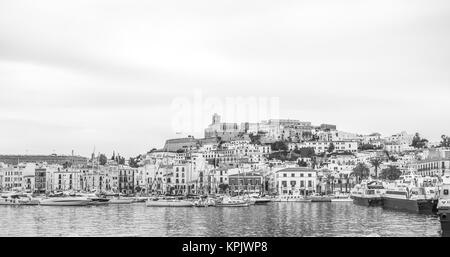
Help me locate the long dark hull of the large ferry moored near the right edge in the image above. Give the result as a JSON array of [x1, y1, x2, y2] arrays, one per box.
[[383, 197, 434, 214]]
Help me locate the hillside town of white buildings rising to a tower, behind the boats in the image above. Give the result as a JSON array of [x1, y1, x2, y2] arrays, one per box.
[[0, 114, 450, 196]]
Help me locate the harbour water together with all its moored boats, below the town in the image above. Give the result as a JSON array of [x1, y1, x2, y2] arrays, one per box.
[[0, 170, 449, 237]]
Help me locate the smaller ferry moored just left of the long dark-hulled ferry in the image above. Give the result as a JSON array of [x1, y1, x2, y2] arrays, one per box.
[[350, 181, 385, 206]]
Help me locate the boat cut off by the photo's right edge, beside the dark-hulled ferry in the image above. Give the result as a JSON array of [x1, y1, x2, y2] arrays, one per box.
[[437, 174, 450, 234]]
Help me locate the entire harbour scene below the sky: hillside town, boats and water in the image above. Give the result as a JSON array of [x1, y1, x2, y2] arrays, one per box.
[[0, 114, 450, 237]]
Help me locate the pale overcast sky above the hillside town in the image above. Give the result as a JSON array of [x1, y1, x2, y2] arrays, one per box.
[[0, 0, 450, 156]]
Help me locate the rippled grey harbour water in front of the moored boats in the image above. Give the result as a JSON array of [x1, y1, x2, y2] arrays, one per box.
[[0, 203, 442, 237]]
